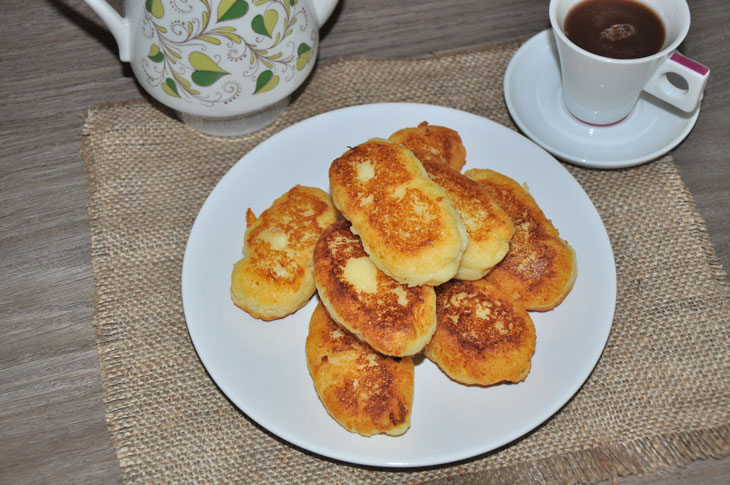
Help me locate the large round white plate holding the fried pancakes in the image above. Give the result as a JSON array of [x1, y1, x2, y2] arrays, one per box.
[[182, 103, 616, 467]]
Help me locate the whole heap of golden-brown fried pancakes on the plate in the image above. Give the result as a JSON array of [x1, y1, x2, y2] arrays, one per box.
[[231, 122, 577, 436]]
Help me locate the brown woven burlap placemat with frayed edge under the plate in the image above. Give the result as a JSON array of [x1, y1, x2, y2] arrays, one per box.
[[83, 38, 730, 483]]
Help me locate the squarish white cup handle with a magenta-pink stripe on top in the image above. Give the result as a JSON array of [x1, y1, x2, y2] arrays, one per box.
[[644, 51, 710, 113]]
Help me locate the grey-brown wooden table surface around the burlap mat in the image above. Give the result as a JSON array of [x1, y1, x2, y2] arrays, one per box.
[[0, 0, 730, 483]]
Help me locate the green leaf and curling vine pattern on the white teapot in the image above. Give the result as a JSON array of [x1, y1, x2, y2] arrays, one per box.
[[143, 0, 313, 106]]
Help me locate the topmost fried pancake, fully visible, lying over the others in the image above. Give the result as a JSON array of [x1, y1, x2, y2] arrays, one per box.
[[329, 139, 468, 286]]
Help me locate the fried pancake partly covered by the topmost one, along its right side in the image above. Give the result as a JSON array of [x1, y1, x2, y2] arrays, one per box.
[[421, 160, 514, 280]]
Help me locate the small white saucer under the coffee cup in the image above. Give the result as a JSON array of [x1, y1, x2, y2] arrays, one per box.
[[504, 29, 700, 168]]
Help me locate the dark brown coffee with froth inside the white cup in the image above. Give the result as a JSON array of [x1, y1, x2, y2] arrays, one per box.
[[563, 0, 665, 59]]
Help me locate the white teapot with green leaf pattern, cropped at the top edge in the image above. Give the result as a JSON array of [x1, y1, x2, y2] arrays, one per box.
[[85, 0, 337, 135]]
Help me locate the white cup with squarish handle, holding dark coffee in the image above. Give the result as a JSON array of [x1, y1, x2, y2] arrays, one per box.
[[549, 0, 710, 125]]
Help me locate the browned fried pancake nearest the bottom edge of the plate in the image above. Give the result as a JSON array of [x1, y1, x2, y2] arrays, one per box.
[[305, 303, 413, 436]]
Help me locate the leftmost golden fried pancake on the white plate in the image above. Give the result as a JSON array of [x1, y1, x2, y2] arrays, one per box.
[[231, 185, 338, 320]]
